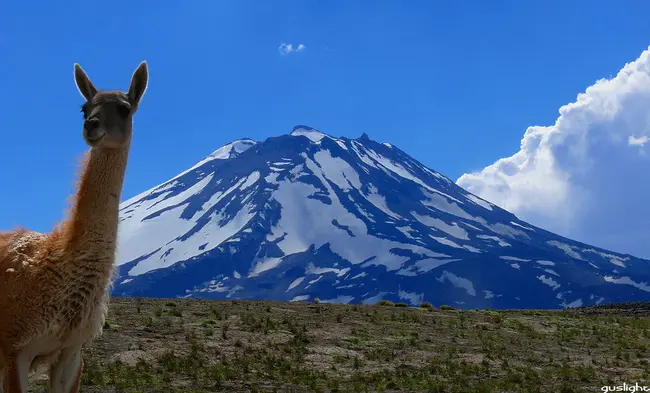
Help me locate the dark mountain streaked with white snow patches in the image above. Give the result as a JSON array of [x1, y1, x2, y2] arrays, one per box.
[[113, 126, 650, 308]]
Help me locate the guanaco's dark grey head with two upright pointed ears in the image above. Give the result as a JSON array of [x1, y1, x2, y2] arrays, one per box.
[[74, 61, 149, 149]]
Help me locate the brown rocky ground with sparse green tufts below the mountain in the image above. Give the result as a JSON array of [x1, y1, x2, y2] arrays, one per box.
[[30, 298, 650, 393]]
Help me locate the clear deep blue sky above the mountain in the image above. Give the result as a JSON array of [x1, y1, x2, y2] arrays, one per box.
[[0, 0, 650, 239]]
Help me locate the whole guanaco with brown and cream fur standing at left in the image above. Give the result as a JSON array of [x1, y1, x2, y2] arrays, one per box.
[[0, 62, 148, 393]]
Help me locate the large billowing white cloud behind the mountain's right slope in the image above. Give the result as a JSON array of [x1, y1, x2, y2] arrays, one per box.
[[457, 45, 650, 257]]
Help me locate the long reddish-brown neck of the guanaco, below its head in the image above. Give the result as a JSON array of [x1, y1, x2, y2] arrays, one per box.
[[65, 141, 129, 267]]
